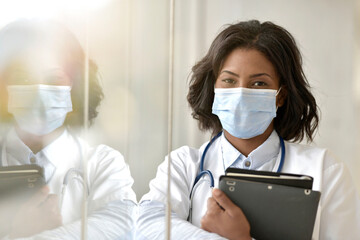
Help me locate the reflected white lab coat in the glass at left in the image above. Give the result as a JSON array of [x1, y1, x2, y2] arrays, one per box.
[[0, 129, 136, 239]]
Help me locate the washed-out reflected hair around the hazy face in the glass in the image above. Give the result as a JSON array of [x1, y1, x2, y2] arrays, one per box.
[[0, 19, 104, 127]]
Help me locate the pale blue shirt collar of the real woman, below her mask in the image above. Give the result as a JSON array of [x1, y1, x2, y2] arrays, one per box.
[[221, 130, 280, 169]]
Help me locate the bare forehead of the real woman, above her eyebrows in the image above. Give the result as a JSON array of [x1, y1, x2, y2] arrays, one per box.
[[221, 48, 276, 76]]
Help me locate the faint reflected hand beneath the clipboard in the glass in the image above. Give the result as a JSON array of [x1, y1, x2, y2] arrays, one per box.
[[9, 186, 62, 238]]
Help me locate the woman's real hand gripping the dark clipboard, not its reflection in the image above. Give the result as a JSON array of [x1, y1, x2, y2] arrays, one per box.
[[201, 189, 251, 240]]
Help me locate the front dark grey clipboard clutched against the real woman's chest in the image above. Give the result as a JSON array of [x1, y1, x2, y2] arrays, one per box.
[[219, 170, 320, 240]]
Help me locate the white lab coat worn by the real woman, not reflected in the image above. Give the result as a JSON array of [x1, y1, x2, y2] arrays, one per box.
[[137, 131, 360, 240]]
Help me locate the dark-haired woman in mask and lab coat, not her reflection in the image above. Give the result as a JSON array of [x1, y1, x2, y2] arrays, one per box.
[[138, 20, 360, 239]]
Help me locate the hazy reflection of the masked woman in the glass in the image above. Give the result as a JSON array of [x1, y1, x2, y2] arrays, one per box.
[[0, 20, 136, 239]]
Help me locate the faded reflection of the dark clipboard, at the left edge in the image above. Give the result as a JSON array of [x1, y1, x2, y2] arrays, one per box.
[[0, 164, 46, 201]]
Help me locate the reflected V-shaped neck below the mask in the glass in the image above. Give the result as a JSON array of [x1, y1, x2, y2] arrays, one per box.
[[15, 126, 65, 154]]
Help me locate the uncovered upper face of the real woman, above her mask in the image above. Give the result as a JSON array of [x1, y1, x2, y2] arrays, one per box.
[[215, 48, 280, 90]]
